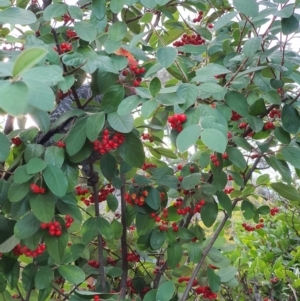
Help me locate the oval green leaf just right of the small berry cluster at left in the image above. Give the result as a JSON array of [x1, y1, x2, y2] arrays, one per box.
[[43, 165, 68, 197]]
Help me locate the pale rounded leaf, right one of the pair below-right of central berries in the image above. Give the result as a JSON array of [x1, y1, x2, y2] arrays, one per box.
[[201, 129, 227, 153]]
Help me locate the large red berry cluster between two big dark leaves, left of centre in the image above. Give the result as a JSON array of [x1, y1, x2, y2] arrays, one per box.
[[93, 129, 125, 155]]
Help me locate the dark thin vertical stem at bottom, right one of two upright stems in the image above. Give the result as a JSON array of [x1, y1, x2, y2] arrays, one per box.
[[120, 174, 128, 300]]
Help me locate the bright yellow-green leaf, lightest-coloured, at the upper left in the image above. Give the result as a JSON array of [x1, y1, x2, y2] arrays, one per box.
[[12, 47, 47, 78]]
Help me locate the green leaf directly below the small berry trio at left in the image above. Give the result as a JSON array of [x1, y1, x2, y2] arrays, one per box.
[[29, 193, 56, 223]]
